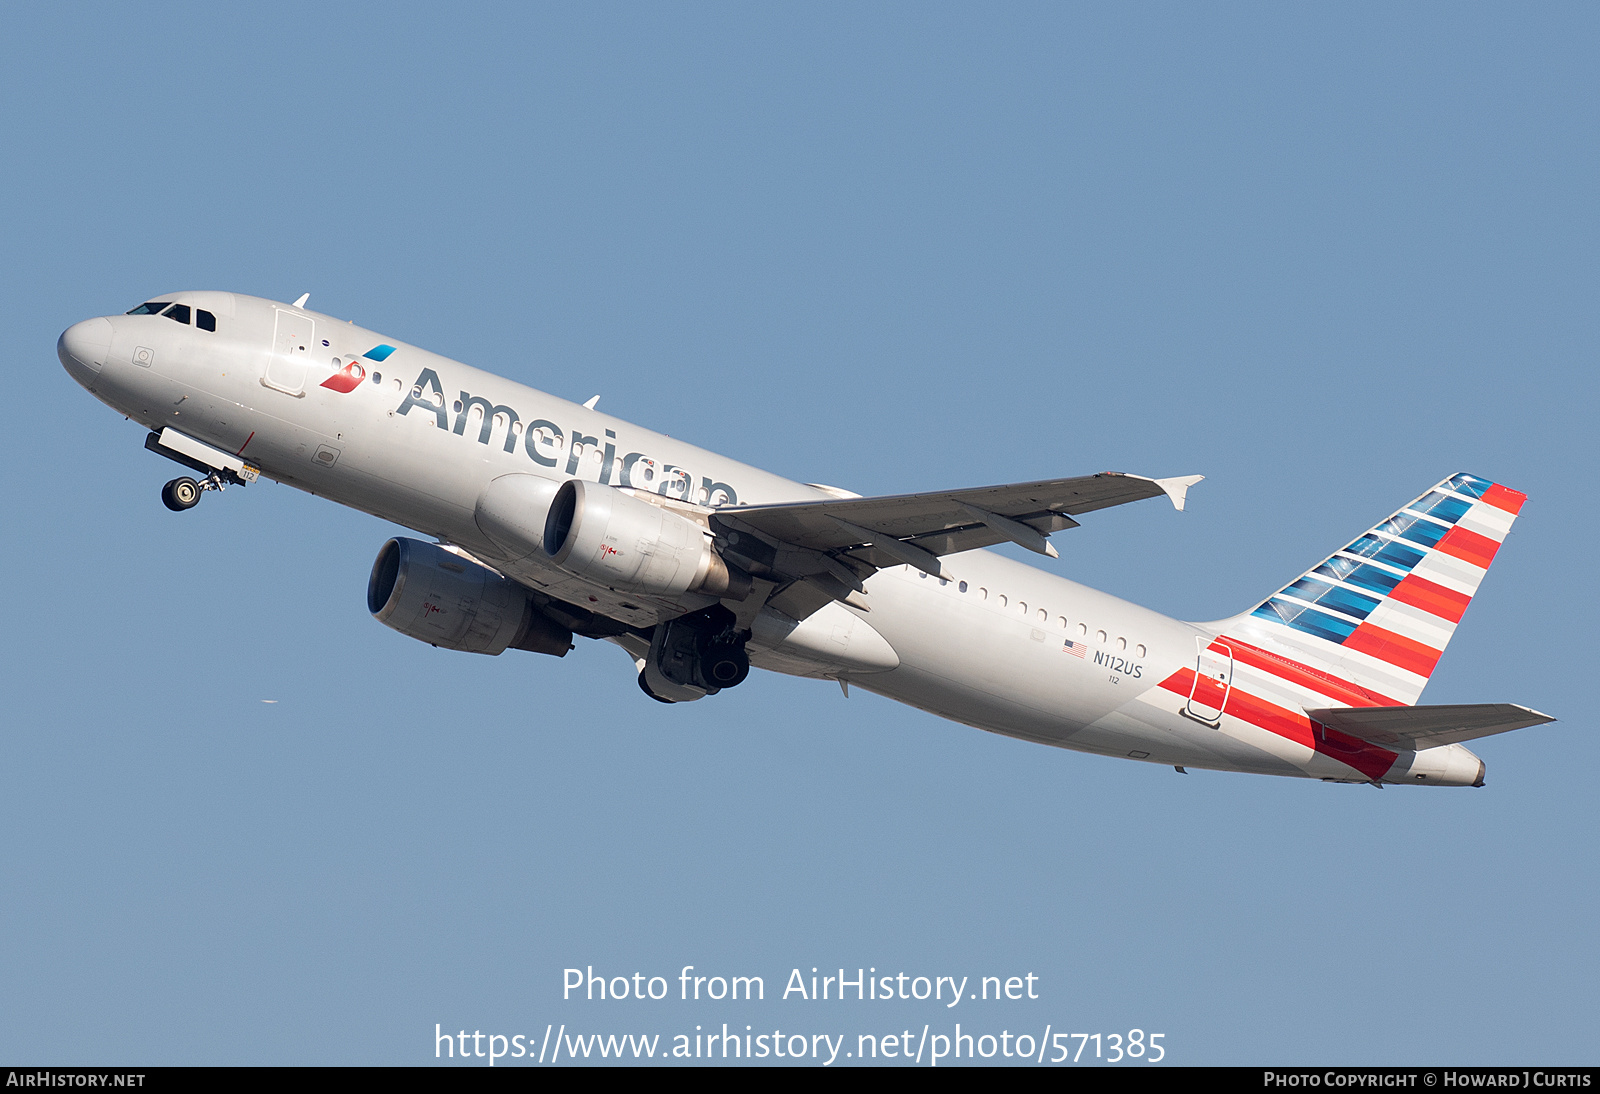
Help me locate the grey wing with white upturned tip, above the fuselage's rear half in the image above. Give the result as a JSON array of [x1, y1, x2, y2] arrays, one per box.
[[710, 472, 1203, 619]]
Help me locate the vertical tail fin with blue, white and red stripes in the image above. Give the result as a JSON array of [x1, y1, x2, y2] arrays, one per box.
[[1213, 475, 1528, 705]]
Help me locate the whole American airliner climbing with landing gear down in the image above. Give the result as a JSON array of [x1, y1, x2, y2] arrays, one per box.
[[58, 291, 1554, 789]]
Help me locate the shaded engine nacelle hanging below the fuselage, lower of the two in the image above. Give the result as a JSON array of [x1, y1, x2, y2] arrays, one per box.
[[366, 539, 573, 657]]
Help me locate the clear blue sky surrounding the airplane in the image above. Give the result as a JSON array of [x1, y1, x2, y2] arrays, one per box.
[[0, 5, 1600, 1064]]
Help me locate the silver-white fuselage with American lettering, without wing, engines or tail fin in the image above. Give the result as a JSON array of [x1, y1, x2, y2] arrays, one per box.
[[59, 293, 1482, 785]]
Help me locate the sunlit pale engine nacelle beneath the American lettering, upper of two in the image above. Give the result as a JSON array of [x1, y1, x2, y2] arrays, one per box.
[[544, 478, 750, 600]]
